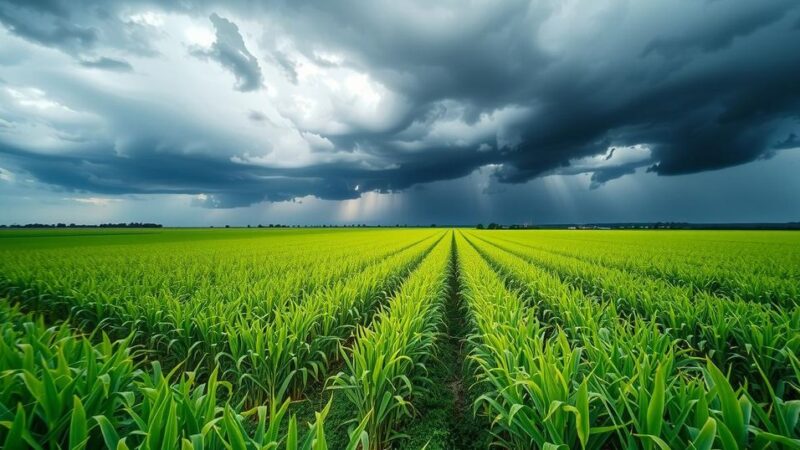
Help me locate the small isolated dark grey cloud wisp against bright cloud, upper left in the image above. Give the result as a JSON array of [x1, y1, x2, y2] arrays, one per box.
[[193, 14, 263, 92]]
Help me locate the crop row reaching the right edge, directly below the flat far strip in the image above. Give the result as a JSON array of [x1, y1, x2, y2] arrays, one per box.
[[466, 230, 800, 395]]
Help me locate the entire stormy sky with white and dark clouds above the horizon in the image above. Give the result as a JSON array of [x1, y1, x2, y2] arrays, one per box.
[[0, 0, 800, 226]]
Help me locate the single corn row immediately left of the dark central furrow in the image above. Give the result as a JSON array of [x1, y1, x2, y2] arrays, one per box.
[[331, 234, 452, 449]]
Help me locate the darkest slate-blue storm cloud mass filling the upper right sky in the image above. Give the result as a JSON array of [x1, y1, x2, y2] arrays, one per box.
[[312, 1, 800, 182]]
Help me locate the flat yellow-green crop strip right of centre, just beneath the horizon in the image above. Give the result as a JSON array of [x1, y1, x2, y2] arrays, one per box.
[[493, 232, 800, 306]]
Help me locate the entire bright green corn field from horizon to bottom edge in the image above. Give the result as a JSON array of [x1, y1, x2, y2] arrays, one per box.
[[0, 228, 800, 450]]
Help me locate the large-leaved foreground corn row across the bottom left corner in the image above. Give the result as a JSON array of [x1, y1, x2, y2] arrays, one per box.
[[0, 300, 369, 450]]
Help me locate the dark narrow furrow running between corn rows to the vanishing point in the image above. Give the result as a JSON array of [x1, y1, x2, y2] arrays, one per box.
[[397, 235, 489, 450]]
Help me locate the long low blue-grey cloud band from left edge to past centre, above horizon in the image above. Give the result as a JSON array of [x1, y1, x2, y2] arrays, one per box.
[[0, 140, 485, 208]]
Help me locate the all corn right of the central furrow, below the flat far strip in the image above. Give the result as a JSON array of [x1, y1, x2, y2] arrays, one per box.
[[459, 232, 800, 449]]
